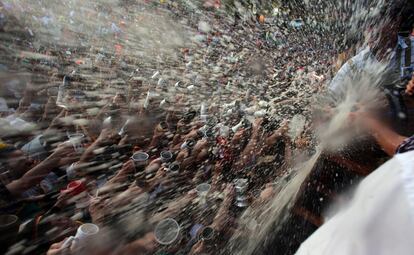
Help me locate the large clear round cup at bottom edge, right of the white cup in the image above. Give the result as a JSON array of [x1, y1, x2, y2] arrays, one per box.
[[154, 218, 180, 245]]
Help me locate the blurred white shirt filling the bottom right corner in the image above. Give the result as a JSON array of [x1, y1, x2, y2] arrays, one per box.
[[296, 151, 414, 255]]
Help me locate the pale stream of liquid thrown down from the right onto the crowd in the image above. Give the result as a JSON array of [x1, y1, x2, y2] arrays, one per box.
[[224, 42, 392, 255]]
